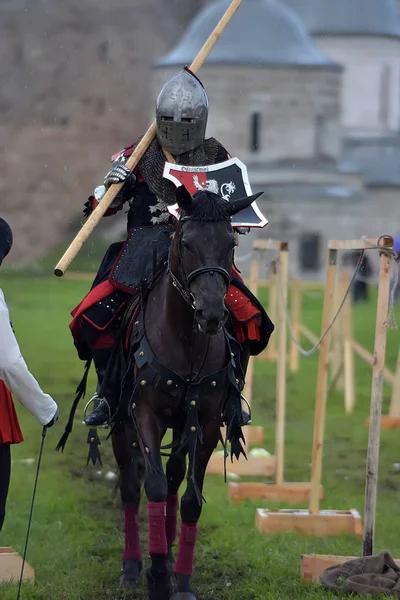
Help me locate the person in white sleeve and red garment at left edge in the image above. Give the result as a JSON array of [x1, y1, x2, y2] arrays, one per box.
[[0, 218, 59, 531]]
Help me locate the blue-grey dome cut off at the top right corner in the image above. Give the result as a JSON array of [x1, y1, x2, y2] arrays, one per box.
[[284, 0, 400, 37]]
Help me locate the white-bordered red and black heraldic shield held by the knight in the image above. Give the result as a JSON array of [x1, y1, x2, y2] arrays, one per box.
[[163, 158, 268, 227]]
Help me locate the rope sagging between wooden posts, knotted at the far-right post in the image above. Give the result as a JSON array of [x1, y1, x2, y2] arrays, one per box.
[[276, 235, 399, 356]]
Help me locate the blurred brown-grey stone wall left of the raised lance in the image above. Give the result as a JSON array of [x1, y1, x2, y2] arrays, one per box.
[[0, 0, 204, 264]]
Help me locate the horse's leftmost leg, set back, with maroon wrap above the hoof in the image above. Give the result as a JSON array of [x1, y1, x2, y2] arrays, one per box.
[[112, 428, 144, 589]]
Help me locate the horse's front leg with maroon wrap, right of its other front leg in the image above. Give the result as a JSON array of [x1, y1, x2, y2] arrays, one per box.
[[171, 420, 219, 600]]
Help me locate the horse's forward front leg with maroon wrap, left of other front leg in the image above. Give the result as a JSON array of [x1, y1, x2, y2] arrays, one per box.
[[137, 401, 173, 600]]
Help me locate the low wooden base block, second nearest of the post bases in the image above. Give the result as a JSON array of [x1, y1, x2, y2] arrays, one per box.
[[256, 508, 362, 537]]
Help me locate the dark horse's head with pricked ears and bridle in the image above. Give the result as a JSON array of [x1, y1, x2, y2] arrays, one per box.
[[169, 186, 261, 335]]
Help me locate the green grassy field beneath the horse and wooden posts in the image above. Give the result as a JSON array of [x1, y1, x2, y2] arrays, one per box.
[[0, 274, 400, 600]]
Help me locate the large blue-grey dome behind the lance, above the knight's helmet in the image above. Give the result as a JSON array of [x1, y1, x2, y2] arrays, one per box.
[[155, 0, 339, 68]]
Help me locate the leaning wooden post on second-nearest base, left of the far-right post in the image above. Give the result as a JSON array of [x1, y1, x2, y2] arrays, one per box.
[[309, 250, 337, 515]]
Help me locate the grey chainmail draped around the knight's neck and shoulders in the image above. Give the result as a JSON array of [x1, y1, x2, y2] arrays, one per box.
[[137, 138, 223, 206]]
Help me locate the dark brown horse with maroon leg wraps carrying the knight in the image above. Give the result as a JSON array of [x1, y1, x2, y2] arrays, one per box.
[[112, 187, 260, 600]]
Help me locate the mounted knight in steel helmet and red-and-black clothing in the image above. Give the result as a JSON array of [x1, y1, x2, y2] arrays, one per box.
[[70, 68, 273, 427]]
